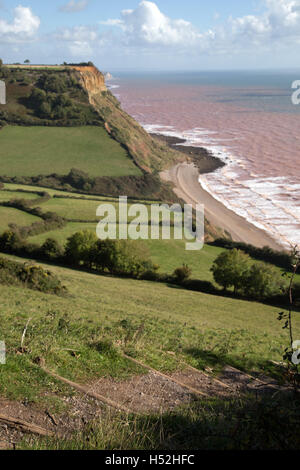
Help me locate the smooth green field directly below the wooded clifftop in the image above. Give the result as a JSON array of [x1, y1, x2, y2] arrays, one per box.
[[0, 126, 141, 177]]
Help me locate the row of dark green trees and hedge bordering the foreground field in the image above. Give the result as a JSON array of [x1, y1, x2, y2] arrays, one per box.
[[0, 230, 300, 305]]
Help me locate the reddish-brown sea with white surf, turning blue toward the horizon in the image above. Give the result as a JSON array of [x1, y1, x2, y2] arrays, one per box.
[[108, 70, 300, 252]]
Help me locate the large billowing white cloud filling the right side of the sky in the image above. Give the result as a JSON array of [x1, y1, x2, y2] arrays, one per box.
[[101, 0, 300, 54]]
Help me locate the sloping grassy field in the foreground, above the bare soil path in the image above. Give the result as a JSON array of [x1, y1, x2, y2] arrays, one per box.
[[0, 253, 300, 408]]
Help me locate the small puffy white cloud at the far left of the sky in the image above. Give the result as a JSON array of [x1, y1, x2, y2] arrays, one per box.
[[0, 5, 40, 43]]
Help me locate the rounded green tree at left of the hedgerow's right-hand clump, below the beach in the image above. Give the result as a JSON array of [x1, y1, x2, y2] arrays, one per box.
[[211, 249, 250, 293]]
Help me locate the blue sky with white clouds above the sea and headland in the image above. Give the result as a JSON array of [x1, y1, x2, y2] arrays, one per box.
[[0, 0, 300, 72]]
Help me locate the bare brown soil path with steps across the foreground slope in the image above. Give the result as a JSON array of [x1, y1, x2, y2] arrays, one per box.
[[0, 366, 288, 449]]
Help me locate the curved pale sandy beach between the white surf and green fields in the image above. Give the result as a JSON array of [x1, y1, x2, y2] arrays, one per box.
[[161, 163, 283, 251]]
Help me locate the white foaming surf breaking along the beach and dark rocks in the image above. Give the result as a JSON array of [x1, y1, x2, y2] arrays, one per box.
[[144, 124, 300, 247]]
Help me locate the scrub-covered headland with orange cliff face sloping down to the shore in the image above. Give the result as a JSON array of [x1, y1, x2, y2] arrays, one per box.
[[0, 65, 186, 172]]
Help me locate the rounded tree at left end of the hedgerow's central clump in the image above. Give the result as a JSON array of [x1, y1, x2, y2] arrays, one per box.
[[65, 230, 98, 267]]
